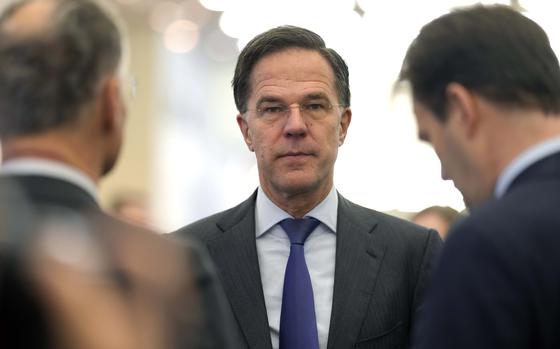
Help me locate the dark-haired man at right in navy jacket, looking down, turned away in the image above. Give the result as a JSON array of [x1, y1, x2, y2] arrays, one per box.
[[400, 5, 560, 349]]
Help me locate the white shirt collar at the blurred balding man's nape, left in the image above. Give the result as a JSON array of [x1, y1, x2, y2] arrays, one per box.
[[0, 157, 98, 201]]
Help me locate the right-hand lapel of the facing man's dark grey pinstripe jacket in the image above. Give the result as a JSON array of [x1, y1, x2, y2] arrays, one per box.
[[327, 195, 385, 349]]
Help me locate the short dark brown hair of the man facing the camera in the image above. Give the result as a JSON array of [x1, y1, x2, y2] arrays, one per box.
[[232, 26, 350, 113]]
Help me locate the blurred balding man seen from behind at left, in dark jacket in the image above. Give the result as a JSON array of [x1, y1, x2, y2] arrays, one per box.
[[0, 0, 234, 349]]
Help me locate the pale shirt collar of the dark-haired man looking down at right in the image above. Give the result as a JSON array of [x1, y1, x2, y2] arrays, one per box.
[[494, 137, 560, 199]]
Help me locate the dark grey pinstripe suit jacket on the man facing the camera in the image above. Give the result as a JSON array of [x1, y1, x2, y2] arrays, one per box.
[[175, 192, 441, 349]]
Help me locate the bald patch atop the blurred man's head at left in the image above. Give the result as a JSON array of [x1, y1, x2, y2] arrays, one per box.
[[1, 0, 55, 38]]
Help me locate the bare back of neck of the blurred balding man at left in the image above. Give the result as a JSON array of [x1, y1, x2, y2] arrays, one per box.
[[2, 134, 100, 184]]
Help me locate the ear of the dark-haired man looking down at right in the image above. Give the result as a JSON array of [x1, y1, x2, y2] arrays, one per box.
[[445, 82, 481, 138]]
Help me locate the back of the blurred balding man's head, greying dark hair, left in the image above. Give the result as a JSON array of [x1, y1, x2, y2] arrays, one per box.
[[0, 0, 122, 138]]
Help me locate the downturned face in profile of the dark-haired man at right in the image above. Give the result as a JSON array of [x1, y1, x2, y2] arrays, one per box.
[[414, 100, 488, 206]]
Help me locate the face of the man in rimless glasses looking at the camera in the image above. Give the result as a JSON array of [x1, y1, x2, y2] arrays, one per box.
[[237, 49, 351, 198]]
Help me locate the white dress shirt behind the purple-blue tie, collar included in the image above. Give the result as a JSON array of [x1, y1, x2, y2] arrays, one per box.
[[255, 187, 338, 349]]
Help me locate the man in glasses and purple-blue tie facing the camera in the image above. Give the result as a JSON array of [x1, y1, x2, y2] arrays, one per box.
[[176, 26, 441, 349]]
